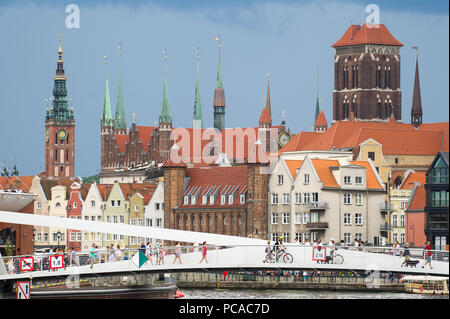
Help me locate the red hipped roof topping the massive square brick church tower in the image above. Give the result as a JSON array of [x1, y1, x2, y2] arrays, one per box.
[[332, 23, 403, 48]]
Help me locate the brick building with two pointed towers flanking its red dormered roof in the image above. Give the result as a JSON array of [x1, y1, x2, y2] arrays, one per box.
[[163, 142, 270, 239]]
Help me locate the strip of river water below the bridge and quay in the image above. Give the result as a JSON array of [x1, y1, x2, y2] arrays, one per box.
[[182, 289, 449, 299]]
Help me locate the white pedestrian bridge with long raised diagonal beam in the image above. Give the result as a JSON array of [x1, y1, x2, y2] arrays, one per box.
[[0, 211, 449, 281]]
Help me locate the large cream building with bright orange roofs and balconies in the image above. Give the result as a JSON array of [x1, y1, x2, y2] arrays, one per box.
[[268, 154, 385, 245]]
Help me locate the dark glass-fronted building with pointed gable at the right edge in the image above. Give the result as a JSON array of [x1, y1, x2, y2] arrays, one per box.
[[425, 151, 449, 250]]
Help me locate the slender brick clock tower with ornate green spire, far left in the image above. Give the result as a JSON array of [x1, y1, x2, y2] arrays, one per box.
[[45, 33, 75, 179]]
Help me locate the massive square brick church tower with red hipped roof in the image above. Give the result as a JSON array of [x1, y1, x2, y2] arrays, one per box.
[[332, 24, 403, 121]]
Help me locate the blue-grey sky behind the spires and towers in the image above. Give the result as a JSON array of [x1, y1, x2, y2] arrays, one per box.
[[0, 0, 449, 176]]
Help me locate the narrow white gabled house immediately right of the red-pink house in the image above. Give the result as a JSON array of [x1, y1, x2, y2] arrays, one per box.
[[81, 182, 105, 251]]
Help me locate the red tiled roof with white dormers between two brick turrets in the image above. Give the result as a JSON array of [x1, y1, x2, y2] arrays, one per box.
[[180, 165, 247, 208]]
